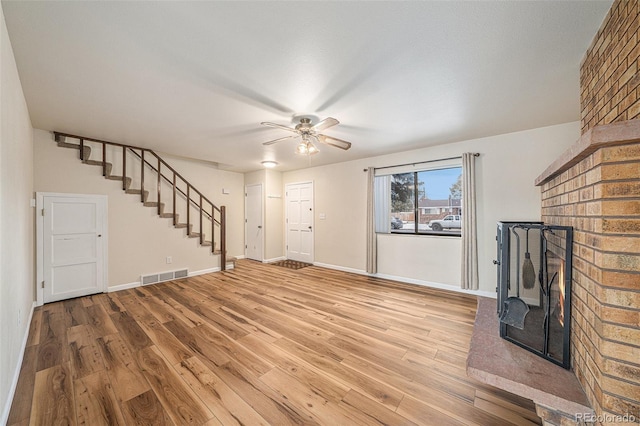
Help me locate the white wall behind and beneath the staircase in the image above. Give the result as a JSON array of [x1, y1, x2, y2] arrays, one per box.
[[34, 130, 244, 287]]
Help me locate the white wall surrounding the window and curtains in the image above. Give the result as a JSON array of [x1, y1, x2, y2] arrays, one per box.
[[283, 122, 580, 294]]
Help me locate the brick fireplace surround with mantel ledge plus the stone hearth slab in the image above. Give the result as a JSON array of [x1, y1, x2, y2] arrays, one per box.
[[467, 119, 640, 425]]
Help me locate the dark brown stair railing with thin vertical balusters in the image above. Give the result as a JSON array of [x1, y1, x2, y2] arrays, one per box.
[[53, 131, 226, 270]]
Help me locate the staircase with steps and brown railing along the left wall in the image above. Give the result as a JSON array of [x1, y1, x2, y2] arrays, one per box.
[[53, 132, 226, 271]]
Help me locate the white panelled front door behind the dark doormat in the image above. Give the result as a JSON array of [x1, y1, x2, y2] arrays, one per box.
[[286, 182, 313, 263]]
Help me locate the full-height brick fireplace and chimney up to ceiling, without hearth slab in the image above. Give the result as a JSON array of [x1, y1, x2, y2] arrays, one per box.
[[536, 0, 640, 424]]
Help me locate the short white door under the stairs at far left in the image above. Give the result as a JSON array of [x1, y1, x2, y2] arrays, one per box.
[[41, 195, 107, 303]]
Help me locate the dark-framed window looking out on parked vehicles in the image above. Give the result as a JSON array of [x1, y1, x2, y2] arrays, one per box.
[[376, 166, 463, 236]]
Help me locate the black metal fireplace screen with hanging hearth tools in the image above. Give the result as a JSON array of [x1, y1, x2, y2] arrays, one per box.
[[495, 222, 573, 369]]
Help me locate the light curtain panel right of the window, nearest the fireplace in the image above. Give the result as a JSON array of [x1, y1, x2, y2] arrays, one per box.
[[461, 152, 479, 290]]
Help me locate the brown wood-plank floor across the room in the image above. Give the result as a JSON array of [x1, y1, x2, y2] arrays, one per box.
[[8, 260, 540, 426]]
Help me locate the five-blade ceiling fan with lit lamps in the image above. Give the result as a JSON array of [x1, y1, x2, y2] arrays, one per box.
[[260, 117, 351, 155]]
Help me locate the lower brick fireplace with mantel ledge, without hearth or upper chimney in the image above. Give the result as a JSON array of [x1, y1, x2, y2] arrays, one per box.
[[537, 120, 640, 423]]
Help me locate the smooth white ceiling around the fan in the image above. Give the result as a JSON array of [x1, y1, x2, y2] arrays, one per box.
[[2, 0, 612, 172]]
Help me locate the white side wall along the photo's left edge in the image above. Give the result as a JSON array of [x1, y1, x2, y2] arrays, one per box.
[[0, 1, 35, 424]]
